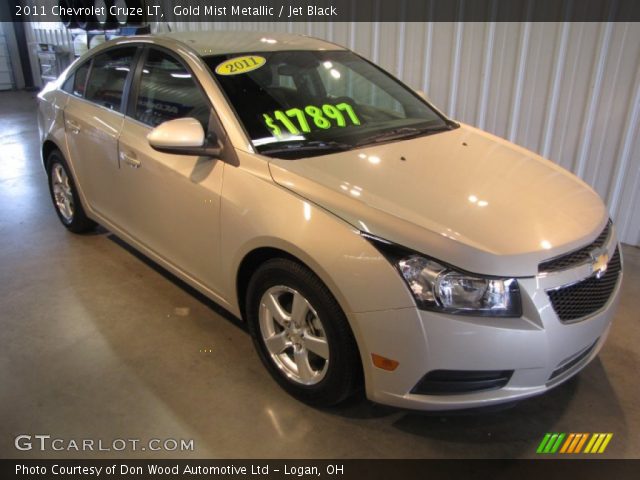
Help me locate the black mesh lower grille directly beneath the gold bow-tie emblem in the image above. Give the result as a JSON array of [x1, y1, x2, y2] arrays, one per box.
[[547, 248, 621, 322]]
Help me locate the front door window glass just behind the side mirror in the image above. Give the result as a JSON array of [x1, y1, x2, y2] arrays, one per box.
[[134, 49, 210, 131]]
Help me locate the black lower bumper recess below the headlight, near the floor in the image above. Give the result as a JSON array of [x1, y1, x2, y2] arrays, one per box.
[[411, 370, 513, 395]]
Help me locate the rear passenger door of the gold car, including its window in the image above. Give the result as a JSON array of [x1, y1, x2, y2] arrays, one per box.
[[64, 46, 138, 221]]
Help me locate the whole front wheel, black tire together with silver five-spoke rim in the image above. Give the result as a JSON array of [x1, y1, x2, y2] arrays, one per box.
[[246, 258, 362, 407]]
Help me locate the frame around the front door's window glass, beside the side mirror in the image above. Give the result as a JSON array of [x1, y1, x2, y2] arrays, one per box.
[[124, 45, 239, 165]]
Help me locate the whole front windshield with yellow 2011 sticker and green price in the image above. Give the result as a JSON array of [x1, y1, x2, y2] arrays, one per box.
[[204, 51, 451, 158]]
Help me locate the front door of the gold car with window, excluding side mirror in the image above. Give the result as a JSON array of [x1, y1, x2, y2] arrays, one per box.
[[118, 47, 225, 290]]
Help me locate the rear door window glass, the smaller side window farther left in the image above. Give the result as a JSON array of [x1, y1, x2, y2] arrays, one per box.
[[85, 47, 136, 111]]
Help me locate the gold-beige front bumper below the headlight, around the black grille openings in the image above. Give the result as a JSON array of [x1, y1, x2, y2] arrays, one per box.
[[354, 248, 622, 410]]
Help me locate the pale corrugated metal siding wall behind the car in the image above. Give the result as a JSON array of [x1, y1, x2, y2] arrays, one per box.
[[23, 20, 640, 245]]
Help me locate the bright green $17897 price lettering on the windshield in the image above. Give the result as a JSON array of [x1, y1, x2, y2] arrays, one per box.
[[262, 102, 360, 137]]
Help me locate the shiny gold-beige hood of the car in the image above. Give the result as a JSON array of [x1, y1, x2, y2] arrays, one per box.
[[269, 125, 607, 276]]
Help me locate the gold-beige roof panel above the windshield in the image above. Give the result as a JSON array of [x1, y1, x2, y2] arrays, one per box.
[[151, 31, 345, 56]]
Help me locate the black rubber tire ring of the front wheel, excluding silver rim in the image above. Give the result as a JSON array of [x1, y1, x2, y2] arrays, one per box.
[[246, 259, 360, 406]]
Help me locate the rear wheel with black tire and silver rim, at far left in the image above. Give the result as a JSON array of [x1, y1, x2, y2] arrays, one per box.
[[47, 150, 96, 233]]
